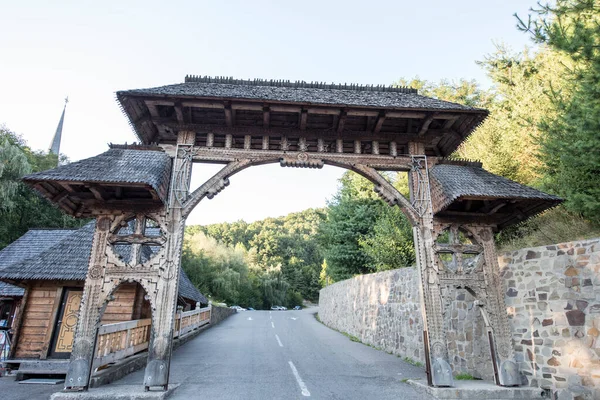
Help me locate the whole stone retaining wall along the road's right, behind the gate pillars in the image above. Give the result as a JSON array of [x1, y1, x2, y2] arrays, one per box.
[[319, 239, 600, 399]]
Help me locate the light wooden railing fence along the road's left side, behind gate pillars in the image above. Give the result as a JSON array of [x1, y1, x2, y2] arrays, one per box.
[[93, 305, 211, 369]]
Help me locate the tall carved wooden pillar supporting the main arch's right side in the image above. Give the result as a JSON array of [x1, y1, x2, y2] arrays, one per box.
[[408, 142, 453, 386]]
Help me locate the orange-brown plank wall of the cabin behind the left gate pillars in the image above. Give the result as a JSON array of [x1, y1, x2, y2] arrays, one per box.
[[12, 281, 150, 359]]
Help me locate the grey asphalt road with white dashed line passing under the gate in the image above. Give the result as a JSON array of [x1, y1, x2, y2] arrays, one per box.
[[111, 309, 432, 400]]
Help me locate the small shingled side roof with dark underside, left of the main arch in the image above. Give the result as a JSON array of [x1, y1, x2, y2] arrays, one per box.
[[23, 148, 171, 215]]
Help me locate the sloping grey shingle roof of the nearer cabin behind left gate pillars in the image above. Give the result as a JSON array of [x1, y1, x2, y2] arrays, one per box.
[[0, 222, 208, 303]]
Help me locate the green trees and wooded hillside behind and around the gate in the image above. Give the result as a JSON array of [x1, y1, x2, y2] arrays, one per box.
[[0, 0, 600, 309]]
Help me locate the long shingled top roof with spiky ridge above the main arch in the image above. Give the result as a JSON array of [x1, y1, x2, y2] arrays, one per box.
[[117, 76, 476, 111]]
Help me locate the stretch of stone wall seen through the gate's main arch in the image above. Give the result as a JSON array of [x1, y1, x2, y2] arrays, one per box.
[[319, 268, 425, 363]]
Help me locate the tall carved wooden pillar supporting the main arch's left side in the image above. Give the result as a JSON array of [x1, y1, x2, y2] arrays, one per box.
[[144, 131, 195, 390]]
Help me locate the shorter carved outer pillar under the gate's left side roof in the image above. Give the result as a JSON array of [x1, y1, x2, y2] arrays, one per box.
[[65, 215, 112, 390]]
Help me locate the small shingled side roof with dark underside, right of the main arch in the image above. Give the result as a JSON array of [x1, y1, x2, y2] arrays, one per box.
[[430, 164, 563, 228]]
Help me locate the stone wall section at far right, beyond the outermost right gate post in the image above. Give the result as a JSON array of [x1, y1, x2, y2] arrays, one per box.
[[498, 239, 600, 399]]
